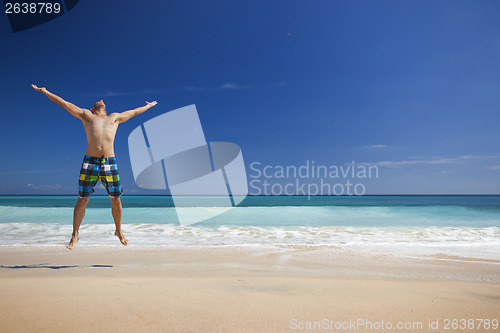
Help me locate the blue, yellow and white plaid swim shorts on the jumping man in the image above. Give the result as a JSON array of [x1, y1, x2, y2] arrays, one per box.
[[78, 155, 123, 198]]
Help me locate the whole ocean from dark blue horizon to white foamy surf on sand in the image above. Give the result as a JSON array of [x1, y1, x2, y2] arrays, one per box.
[[0, 196, 500, 261]]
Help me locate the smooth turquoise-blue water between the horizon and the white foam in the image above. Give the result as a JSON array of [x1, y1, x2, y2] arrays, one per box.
[[0, 196, 500, 228]]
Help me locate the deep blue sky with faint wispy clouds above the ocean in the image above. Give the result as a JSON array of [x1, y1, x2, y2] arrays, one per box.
[[0, 0, 500, 194]]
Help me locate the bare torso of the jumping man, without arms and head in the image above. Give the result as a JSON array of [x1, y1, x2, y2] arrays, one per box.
[[82, 110, 119, 157]]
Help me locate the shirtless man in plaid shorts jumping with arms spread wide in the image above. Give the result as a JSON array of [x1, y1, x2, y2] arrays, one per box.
[[31, 84, 156, 250]]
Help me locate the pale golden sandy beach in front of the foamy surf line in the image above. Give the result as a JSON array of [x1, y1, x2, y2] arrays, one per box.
[[0, 246, 500, 332]]
